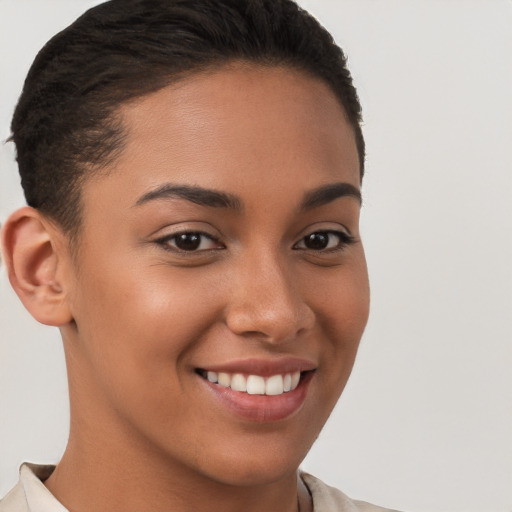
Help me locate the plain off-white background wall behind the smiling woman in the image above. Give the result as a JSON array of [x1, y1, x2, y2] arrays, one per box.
[[0, 0, 512, 512]]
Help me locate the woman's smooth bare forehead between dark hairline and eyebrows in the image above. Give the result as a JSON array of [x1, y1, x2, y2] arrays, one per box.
[[84, 64, 359, 212]]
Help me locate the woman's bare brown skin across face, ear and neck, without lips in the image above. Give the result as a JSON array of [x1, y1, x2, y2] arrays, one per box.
[[0, 64, 369, 512]]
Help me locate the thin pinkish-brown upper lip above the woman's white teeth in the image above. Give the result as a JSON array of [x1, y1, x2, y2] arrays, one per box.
[[200, 357, 316, 377]]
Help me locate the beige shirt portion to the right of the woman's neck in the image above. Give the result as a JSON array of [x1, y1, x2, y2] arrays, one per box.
[[300, 472, 404, 512]]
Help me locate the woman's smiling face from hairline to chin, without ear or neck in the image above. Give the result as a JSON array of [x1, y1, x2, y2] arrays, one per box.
[[63, 65, 369, 485]]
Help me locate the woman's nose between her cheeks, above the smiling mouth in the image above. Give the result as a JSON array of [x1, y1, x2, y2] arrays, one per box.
[[226, 254, 315, 344]]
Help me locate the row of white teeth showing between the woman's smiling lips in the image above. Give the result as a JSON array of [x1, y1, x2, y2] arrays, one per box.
[[196, 369, 312, 396]]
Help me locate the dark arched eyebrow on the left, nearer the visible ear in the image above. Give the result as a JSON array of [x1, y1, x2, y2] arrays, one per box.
[[135, 183, 242, 211]]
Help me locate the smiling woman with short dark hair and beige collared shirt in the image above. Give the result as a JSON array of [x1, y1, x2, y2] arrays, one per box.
[[0, 0, 398, 512]]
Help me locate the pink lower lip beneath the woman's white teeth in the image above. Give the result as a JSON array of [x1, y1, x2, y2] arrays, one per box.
[[199, 372, 313, 423]]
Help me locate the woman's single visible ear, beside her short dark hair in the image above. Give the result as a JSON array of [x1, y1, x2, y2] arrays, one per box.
[[2, 206, 73, 326]]
